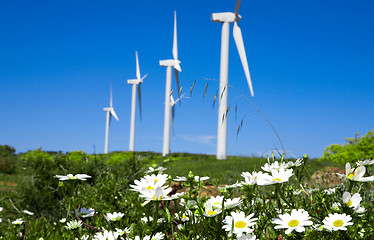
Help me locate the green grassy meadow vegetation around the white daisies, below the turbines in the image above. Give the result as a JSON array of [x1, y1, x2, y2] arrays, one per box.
[[0, 144, 374, 240]]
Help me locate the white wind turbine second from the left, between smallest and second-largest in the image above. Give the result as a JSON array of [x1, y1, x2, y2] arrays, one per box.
[[127, 51, 148, 152]]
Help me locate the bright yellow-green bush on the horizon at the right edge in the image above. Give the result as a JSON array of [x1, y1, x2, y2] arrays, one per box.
[[321, 130, 374, 163]]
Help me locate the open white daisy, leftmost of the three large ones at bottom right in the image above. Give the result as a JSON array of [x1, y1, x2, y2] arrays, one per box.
[[222, 211, 257, 238]]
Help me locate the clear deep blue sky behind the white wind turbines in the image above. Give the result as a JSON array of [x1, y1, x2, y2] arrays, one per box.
[[0, 0, 374, 157]]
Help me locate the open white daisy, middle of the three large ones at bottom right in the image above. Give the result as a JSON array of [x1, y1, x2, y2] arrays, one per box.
[[273, 209, 313, 235]]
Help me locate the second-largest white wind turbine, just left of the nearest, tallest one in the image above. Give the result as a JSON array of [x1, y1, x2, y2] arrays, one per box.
[[160, 12, 182, 156]]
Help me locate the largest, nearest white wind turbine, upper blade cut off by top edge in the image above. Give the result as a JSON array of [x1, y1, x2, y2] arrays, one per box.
[[212, 0, 254, 159]]
